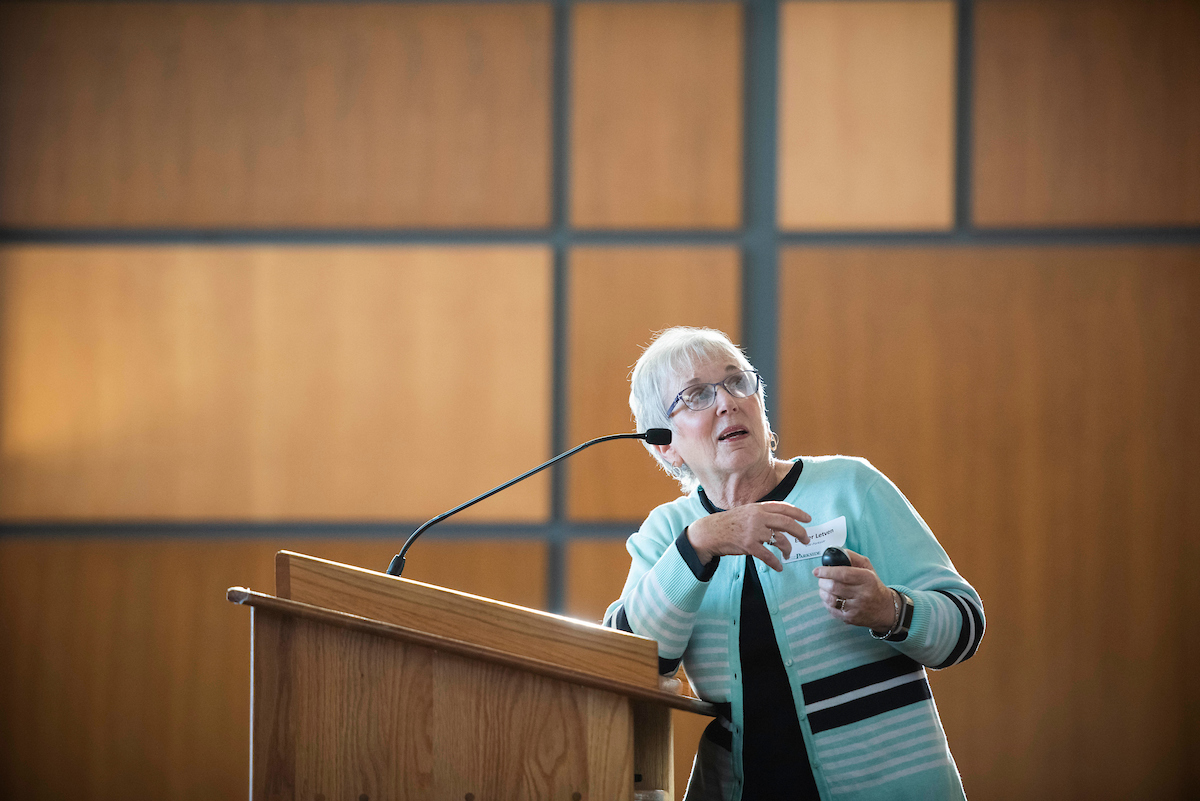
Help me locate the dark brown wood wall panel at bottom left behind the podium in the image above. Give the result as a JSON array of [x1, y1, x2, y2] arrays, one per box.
[[0, 537, 546, 801]]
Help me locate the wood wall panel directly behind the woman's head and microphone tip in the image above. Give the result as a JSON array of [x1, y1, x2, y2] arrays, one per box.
[[566, 247, 742, 522]]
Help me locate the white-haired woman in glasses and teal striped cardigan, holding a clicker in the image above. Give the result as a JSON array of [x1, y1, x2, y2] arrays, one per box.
[[605, 327, 984, 801]]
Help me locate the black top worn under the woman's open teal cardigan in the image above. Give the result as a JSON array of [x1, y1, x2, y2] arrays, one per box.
[[678, 459, 821, 801]]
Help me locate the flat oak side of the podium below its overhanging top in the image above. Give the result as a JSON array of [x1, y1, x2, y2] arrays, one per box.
[[251, 608, 634, 800]]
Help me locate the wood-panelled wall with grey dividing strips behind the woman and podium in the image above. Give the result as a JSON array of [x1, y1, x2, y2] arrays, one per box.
[[0, 0, 1200, 801]]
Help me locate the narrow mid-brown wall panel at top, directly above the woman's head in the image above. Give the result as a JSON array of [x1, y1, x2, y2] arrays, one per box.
[[570, 2, 743, 228]]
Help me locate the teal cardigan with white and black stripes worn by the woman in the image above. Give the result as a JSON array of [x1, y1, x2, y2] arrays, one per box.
[[605, 456, 984, 801]]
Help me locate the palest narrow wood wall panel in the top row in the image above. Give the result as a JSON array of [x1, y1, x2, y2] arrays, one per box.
[[779, 0, 955, 230]]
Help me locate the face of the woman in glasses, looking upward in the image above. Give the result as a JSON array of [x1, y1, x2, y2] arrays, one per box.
[[660, 361, 770, 487]]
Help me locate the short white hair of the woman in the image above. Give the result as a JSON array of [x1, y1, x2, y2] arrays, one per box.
[[629, 326, 770, 493]]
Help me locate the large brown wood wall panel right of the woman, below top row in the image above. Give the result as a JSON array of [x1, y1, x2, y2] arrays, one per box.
[[776, 247, 1200, 799]]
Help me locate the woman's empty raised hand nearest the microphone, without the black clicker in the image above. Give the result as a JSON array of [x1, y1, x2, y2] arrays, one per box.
[[688, 501, 812, 572]]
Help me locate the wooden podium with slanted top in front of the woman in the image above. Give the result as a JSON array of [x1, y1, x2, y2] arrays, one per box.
[[228, 550, 713, 801]]
